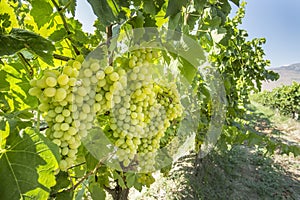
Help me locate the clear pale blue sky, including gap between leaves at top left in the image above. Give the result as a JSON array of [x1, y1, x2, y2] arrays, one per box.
[[76, 0, 300, 67]]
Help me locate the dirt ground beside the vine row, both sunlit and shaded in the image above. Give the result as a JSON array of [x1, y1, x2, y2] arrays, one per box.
[[130, 104, 300, 200]]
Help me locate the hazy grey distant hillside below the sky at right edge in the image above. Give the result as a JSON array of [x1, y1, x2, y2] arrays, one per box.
[[262, 63, 300, 90]]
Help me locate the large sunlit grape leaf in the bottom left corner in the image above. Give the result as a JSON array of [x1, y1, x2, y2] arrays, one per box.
[[0, 128, 58, 200]]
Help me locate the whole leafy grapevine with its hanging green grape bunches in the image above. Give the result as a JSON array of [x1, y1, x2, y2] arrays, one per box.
[[0, 0, 299, 199]]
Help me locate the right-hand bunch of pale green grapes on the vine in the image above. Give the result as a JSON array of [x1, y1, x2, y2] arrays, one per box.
[[103, 49, 182, 171]]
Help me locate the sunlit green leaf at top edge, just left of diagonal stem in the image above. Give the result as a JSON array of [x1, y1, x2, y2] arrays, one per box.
[[30, 0, 53, 28]]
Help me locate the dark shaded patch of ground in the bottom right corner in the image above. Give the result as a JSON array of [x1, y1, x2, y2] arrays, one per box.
[[169, 146, 300, 200]]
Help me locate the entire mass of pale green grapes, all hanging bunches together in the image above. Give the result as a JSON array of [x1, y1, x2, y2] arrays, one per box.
[[30, 49, 182, 171]]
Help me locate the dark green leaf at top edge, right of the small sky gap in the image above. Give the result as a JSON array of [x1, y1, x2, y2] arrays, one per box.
[[88, 0, 117, 26]]
